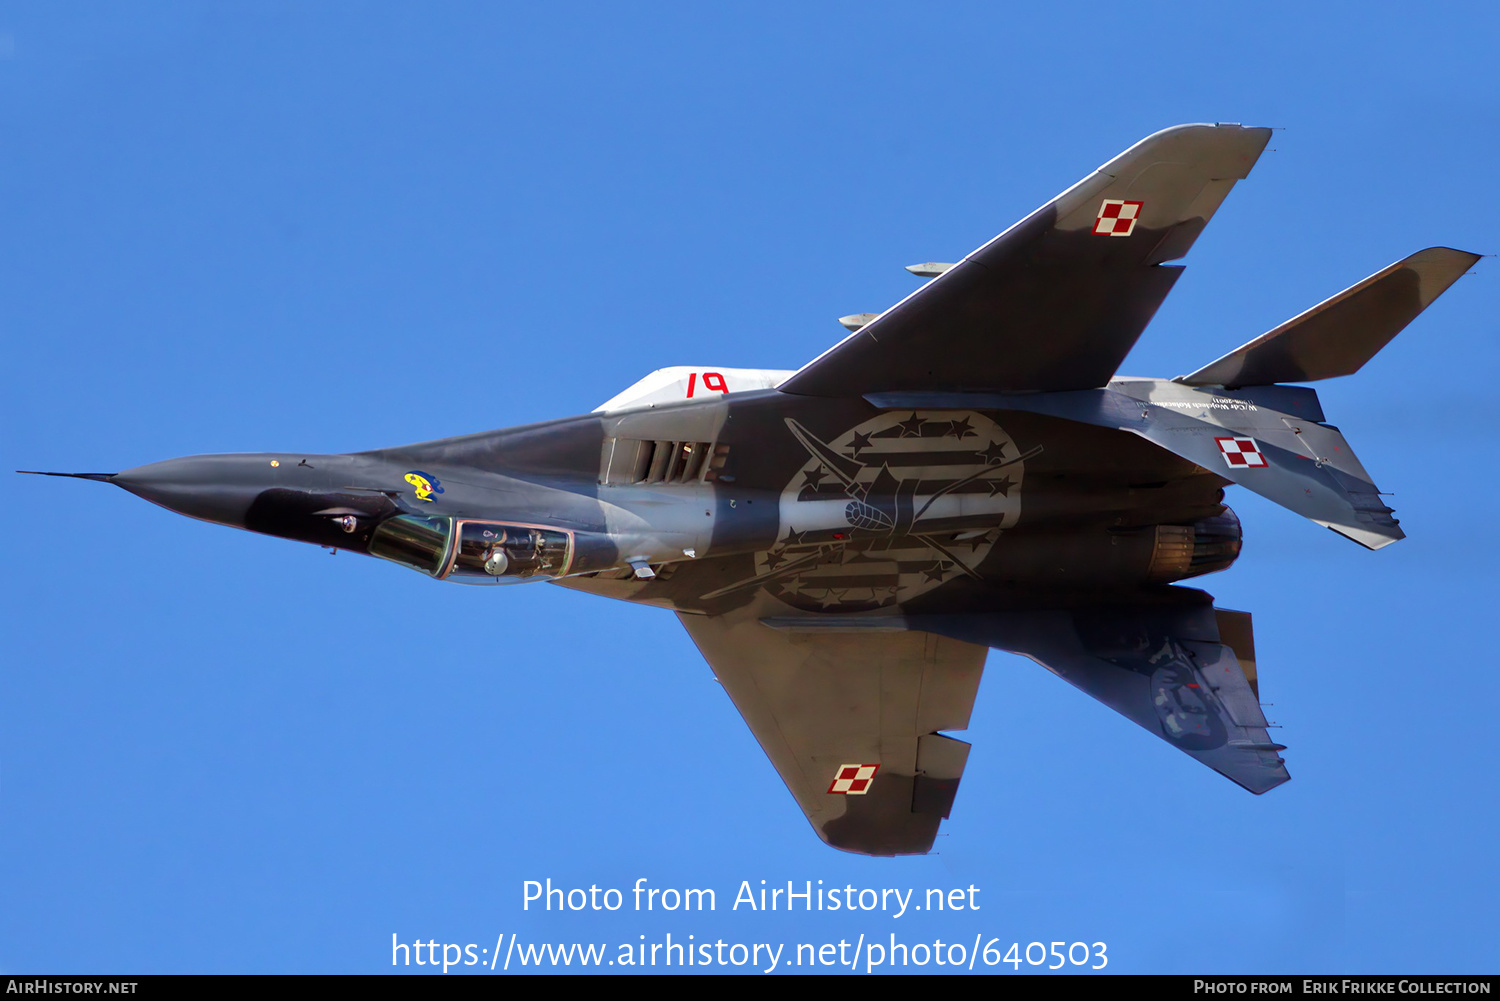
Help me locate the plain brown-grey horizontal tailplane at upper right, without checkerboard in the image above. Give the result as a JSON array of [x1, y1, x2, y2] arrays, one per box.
[[1175, 246, 1479, 387]]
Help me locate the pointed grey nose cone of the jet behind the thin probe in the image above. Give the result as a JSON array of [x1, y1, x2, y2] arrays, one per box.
[[110, 455, 276, 528]]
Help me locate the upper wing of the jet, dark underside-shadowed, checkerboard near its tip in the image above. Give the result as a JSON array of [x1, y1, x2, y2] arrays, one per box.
[[780, 125, 1271, 396]]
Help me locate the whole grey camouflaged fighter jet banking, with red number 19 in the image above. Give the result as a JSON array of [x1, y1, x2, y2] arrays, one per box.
[[20, 125, 1478, 855]]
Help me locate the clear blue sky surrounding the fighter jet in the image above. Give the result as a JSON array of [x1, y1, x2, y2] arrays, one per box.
[[0, 3, 1500, 975]]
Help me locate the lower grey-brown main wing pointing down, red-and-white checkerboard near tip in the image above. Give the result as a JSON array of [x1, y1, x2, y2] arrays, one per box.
[[678, 600, 987, 855]]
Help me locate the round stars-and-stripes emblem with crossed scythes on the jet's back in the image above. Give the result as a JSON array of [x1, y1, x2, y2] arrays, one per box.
[[705, 410, 1041, 612]]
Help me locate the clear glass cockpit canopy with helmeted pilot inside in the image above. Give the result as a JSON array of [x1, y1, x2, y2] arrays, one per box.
[[369, 515, 573, 584]]
